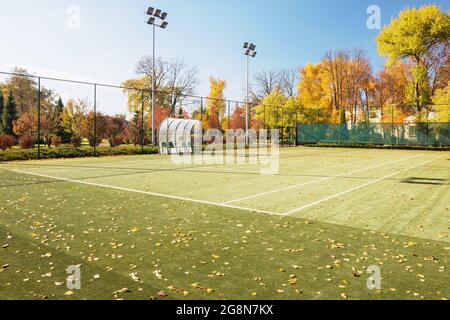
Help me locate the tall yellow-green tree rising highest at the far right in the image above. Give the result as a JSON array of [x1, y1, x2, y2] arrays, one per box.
[[376, 5, 450, 112]]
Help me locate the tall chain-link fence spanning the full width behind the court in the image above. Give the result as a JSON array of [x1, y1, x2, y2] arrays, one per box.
[[0, 72, 450, 158]]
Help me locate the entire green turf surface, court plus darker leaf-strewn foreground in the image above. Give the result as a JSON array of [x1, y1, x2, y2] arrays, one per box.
[[0, 148, 450, 299]]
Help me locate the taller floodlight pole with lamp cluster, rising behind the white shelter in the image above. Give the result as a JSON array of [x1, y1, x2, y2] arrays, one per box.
[[146, 7, 169, 146]]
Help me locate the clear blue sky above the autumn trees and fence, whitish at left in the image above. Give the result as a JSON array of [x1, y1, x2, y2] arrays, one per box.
[[0, 0, 450, 112]]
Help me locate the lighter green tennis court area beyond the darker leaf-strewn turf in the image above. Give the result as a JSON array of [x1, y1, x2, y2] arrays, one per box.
[[3, 148, 450, 242]]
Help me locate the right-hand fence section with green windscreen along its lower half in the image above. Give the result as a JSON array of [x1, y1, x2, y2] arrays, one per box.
[[297, 105, 450, 147]]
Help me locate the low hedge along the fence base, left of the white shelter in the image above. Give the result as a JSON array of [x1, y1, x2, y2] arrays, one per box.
[[0, 146, 158, 162]]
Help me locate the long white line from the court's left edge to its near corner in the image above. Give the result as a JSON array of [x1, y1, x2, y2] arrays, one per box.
[[9, 169, 281, 216]]
